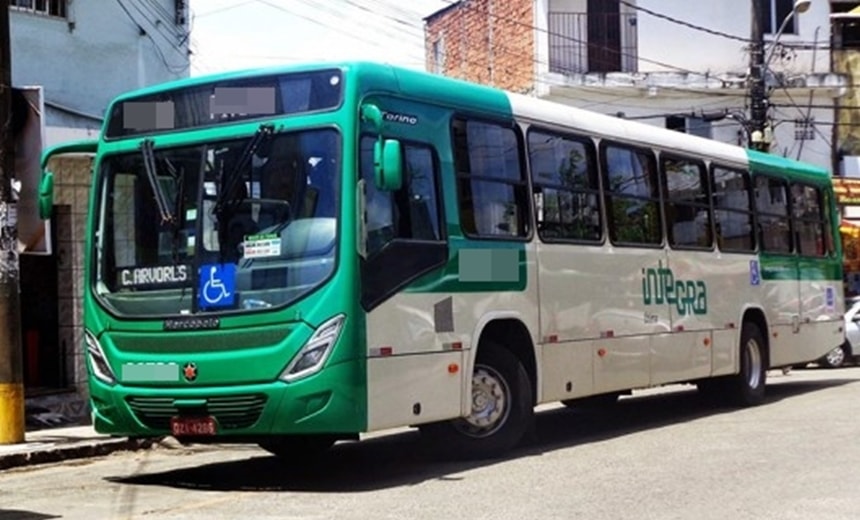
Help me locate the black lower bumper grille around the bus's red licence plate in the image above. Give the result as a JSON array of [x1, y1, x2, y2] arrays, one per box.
[[126, 394, 266, 430]]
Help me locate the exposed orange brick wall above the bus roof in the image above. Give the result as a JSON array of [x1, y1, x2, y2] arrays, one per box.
[[424, 0, 536, 93]]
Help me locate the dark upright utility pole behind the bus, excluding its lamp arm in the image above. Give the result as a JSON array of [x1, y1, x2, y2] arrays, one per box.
[[747, 0, 770, 152]]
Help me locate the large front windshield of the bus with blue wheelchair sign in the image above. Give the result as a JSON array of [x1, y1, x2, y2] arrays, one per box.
[[93, 130, 340, 316]]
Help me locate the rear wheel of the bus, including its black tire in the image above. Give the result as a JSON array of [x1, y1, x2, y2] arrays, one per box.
[[727, 321, 767, 406]]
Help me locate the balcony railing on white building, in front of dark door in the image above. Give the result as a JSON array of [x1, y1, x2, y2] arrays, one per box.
[[548, 13, 638, 74]]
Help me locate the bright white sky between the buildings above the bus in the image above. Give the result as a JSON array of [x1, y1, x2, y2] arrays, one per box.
[[190, 0, 446, 76]]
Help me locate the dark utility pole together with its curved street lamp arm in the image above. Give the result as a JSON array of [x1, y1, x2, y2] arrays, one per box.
[[749, 0, 812, 152]]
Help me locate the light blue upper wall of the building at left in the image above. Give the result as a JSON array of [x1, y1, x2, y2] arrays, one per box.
[[10, 0, 190, 128]]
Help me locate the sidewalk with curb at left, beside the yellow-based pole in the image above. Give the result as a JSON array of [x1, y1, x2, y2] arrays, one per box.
[[0, 426, 154, 471]]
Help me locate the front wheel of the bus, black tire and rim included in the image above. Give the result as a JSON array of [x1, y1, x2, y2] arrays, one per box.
[[421, 341, 534, 459]]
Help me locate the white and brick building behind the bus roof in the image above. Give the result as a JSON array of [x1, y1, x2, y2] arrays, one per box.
[[425, 0, 856, 169]]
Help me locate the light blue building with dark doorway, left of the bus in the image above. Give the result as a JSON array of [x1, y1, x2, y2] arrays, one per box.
[[10, 0, 190, 419]]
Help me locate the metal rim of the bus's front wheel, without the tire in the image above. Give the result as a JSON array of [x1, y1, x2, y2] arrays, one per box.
[[457, 365, 510, 437]]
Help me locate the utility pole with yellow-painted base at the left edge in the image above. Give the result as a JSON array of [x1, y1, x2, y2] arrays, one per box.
[[0, 0, 24, 444]]
